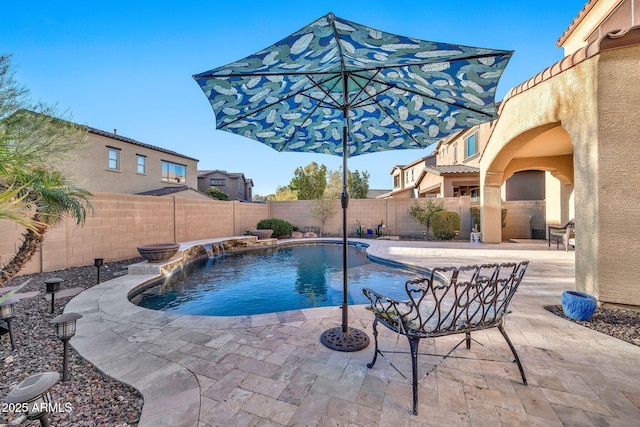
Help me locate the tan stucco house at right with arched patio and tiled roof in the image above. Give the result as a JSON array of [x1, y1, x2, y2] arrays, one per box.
[[479, 0, 640, 306]]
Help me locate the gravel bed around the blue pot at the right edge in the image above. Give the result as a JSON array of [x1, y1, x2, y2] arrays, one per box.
[[545, 305, 640, 346]]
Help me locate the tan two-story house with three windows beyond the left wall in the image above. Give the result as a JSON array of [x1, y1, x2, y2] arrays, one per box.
[[63, 127, 200, 197]]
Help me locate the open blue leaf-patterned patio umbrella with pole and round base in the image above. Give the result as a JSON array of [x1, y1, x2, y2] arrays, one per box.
[[193, 13, 513, 351]]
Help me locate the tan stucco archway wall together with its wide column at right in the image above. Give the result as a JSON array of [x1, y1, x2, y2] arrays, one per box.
[[481, 41, 640, 305]]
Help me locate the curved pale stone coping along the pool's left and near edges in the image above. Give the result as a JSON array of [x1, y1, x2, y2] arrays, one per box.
[[64, 236, 378, 426]]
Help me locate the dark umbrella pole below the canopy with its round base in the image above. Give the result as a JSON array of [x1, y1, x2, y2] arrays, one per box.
[[320, 122, 369, 351]]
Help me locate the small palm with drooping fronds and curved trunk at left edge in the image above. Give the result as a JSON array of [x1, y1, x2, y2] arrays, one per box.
[[0, 168, 91, 286]]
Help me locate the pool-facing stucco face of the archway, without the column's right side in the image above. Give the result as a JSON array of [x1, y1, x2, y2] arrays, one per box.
[[480, 56, 599, 292]]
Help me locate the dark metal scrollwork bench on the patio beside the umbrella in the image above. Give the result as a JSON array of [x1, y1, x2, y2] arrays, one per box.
[[363, 261, 529, 414]]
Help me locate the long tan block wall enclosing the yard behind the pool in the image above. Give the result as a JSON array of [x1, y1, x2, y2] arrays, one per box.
[[0, 193, 544, 274]]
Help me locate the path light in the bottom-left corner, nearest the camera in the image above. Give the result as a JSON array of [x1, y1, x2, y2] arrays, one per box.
[[5, 372, 60, 427]]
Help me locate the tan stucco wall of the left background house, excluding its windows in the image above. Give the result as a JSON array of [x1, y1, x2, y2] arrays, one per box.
[[62, 133, 198, 194]]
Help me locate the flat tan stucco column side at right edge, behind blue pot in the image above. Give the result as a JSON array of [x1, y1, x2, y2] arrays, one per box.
[[592, 42, 640, 305]]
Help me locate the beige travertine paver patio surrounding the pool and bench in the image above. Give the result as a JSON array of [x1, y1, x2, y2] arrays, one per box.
[[65, 240, 640, 426]]
